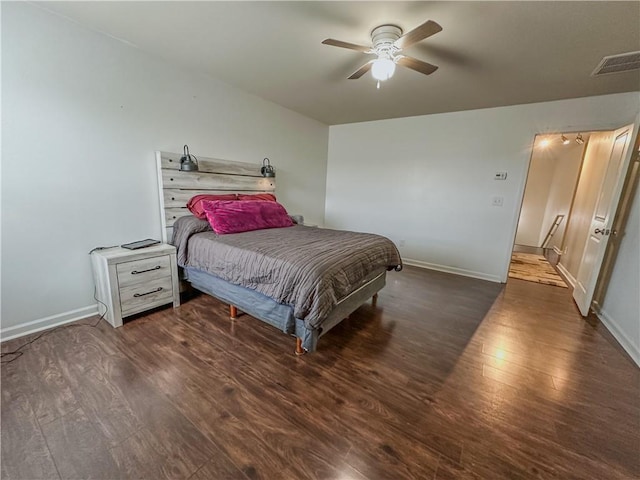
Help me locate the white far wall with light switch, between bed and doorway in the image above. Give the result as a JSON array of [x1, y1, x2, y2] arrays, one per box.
[[325, 92, 640, 281]]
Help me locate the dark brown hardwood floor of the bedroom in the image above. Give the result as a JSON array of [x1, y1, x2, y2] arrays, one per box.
[[1, 267, 640, 480]]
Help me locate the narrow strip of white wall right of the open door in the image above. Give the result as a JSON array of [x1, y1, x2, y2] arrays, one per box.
[[598, 188, 640, 366]]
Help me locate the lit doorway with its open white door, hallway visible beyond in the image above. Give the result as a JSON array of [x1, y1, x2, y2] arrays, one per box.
[[509, 123, 640, 316]]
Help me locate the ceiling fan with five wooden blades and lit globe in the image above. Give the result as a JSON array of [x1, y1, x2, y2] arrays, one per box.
[[322, 20, 442, 88]]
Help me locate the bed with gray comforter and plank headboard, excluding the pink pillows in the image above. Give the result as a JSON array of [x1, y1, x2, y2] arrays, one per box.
[[156, 152, 402, 355]]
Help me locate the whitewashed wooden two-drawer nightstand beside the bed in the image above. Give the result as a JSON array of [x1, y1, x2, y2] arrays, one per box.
[[91, 244, 180, 327]]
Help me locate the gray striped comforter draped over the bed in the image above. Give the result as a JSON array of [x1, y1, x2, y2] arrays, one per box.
[[172, 216, 402, 329]]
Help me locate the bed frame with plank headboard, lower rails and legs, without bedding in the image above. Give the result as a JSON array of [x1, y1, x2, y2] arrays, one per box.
[[156, 151, 386, 355]]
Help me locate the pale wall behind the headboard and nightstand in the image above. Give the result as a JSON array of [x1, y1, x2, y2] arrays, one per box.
[[1, 2, 329, 338]]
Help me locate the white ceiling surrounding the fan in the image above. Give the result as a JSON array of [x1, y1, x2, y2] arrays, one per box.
[[38, 1, 640, 125]]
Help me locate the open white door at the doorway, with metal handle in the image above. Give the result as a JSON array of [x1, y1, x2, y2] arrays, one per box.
[[573, 125, 633, 317]]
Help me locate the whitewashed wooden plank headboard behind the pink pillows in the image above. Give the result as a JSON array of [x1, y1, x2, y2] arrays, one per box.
[[156, 152, 276, 242]]
